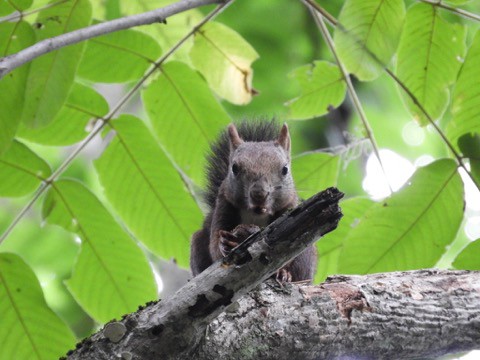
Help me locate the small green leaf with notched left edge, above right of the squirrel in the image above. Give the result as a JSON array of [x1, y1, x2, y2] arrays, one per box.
[[285, 61, 347, 120]]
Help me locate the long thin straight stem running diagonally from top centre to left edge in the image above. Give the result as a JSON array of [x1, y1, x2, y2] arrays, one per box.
[[0, 0, 233, 244]]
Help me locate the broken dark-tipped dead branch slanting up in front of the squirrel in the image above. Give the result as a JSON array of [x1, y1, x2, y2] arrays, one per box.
[[65, 188, 343, 360]]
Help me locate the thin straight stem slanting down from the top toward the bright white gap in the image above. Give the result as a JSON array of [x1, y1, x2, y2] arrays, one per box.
[[302, 0, 393, 193]]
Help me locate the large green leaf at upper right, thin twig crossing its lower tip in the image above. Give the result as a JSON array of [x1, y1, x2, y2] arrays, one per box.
[[397, 3, 466, 125]]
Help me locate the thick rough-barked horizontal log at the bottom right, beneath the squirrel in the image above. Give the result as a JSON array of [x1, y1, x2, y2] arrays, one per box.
[[198, 272, 480, 360]]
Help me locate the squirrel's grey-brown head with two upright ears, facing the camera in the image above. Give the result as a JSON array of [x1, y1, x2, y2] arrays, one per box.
[[225, 124, 296, 216]]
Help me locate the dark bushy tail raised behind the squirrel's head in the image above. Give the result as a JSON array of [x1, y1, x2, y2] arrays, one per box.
[[205, 120, 280, 208]]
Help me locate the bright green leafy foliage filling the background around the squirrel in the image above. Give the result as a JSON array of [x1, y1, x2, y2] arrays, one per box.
[[0, 0, 480, 359]]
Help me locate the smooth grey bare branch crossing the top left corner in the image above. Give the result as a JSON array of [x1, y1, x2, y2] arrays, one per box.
[[0, 0, 223, 79]]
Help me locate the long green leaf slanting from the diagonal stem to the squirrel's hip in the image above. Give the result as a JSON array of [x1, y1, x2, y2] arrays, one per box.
[[95, 115, 202, 266]]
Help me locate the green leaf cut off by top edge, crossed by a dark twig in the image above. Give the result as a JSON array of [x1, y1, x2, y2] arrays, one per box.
[[334, 0, 405, 81]]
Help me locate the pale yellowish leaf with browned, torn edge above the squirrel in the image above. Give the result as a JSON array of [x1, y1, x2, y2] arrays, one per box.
[[190, 22, 258, 105]]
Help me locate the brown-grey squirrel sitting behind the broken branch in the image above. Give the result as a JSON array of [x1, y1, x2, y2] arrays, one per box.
[[190, 120, 317, 283]]
